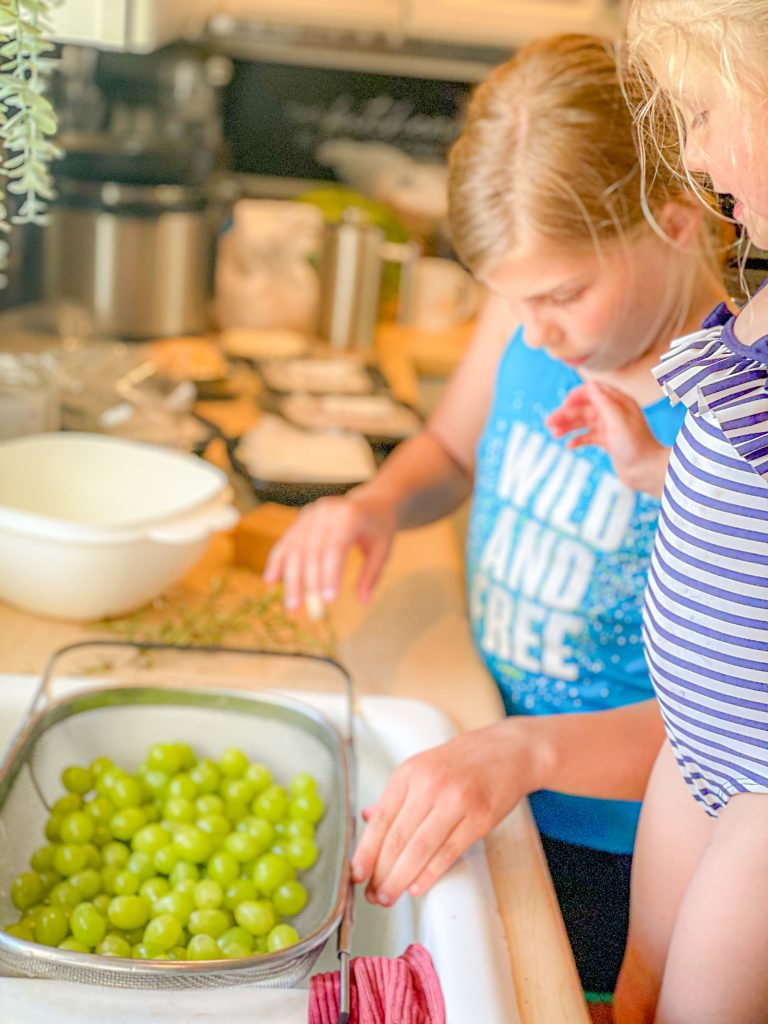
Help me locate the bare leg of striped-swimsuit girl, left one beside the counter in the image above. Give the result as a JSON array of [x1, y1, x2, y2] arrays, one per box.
[[613, 740, 722, 1024]]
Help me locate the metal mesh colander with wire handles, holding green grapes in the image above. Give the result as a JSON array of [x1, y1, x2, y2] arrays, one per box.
[[0, 643, 352, 988]]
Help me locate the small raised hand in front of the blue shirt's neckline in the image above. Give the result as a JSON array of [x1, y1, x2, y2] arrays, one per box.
[[546, 381, 670, 497]]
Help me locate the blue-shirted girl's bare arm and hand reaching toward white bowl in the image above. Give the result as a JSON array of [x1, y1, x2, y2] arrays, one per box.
[[264, 299, 512, 608]]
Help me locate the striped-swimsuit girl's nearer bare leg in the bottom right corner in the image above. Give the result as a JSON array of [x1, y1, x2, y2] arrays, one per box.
[[656, 793, 768, 1024]]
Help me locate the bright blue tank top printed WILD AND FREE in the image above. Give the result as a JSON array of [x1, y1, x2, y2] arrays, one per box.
[[467, 331, 684, 853]]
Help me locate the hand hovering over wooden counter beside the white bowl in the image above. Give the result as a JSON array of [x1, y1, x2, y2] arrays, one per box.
[[264, 495, 396, 613]]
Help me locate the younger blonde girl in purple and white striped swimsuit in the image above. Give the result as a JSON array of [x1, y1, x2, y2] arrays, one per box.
[[553, 0, 768, 1024]]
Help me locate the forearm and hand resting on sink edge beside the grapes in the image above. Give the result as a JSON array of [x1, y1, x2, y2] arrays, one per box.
[[352, 700, 664, 905]]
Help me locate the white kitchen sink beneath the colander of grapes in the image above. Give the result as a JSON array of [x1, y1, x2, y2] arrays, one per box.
[[0, 675, 519, 1024]]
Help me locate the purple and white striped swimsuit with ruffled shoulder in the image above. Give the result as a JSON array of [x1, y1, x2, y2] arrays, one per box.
[[643, 306, 768, 816]]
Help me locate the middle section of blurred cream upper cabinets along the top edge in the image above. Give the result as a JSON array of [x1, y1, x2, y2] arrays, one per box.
[[210, 0, 407, 33]]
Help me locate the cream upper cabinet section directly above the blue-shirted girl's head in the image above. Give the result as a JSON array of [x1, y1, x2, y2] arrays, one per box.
[[403, 0, 618, 47]]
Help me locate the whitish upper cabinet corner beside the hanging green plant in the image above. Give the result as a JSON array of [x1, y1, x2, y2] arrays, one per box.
[[51, 0, 218, 53]]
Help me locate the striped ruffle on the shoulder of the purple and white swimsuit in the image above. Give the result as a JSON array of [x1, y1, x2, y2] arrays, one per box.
[[653, 307, 768, 480]]
